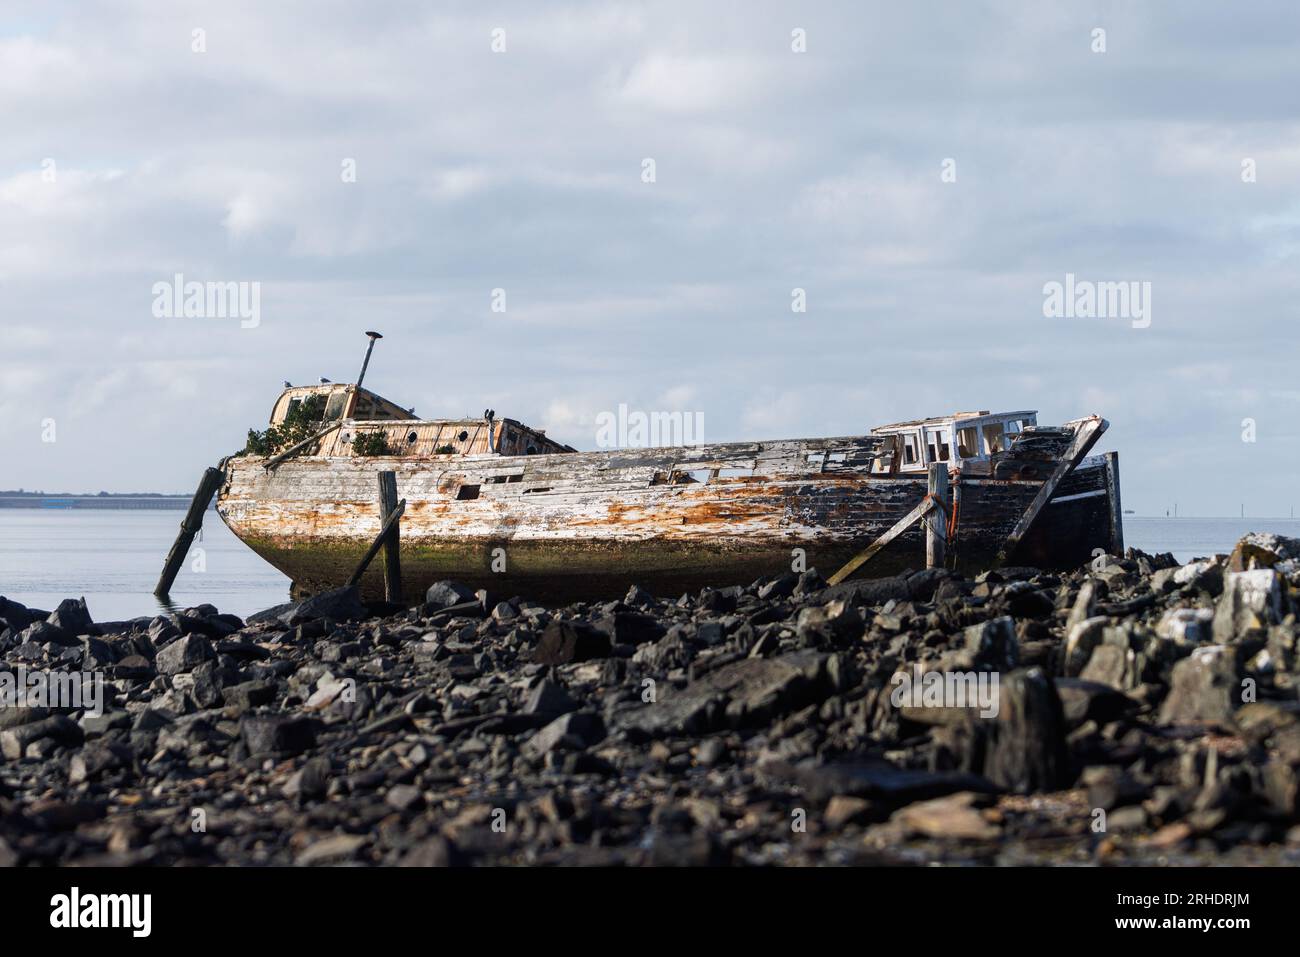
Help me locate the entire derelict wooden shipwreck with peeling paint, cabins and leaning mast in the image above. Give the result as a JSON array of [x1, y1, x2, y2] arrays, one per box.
[[160, 334, 1123, 602]]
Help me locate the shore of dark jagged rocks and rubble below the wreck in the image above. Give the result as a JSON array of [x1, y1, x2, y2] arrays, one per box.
[[0, 534, 1300, 865]]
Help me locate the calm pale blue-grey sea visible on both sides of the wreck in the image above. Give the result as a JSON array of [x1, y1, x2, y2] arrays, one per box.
[[0, 508, 1300, 622]]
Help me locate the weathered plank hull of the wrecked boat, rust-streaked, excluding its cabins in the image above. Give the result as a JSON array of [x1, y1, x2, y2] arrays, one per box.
[[217, 437, 1122, 602]]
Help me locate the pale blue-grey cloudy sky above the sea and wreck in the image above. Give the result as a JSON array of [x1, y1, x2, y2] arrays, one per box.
[[0, 0, 1300, 516]]
